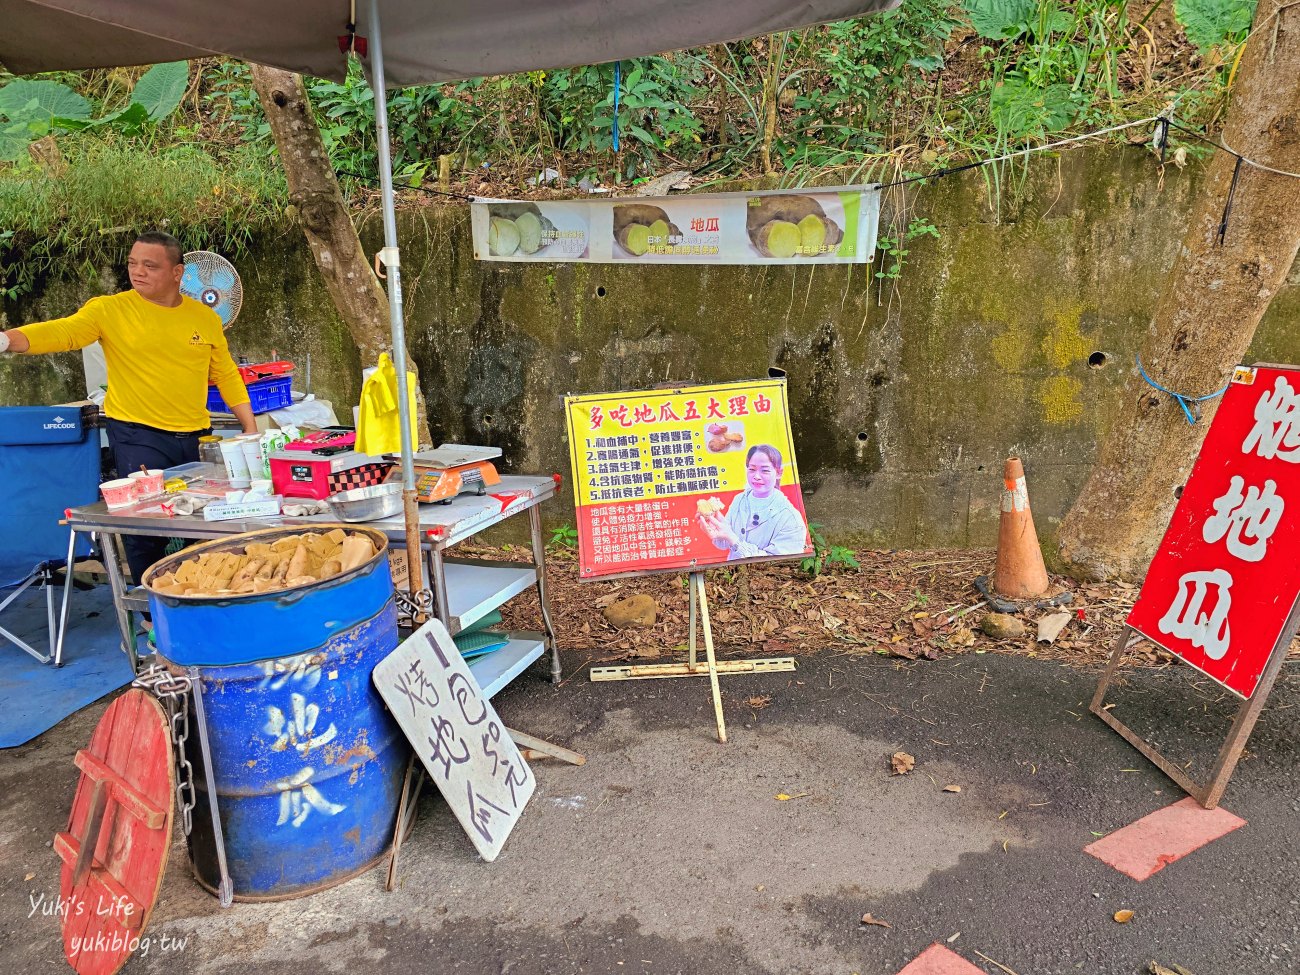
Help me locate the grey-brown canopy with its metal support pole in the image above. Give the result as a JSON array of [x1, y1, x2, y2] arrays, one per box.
[[0, 0, 900, 589]]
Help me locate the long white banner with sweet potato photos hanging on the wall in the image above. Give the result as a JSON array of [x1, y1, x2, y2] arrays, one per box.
[[469, 186, 880, 264]]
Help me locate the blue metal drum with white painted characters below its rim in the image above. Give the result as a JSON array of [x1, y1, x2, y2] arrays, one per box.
[[144, 524, 411, 901]]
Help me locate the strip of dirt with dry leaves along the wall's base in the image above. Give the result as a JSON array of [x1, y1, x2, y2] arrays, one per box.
[[488, 545, 1300, 667]]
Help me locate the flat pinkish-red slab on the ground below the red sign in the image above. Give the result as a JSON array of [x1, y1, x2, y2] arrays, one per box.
[[1083, 796, 1245, 880]]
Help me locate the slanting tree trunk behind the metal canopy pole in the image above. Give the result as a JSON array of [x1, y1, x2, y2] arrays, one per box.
[[252, 65, 429, 443]]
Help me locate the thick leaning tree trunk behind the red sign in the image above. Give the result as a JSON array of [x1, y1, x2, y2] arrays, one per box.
[[1060, 0, 1300, 579]]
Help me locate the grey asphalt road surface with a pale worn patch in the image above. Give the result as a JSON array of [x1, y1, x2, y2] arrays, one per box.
[[0, 644, 1300, 975]]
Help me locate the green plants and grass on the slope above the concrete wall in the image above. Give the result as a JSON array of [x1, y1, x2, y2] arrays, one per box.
[[0, 0, 1255, 299]]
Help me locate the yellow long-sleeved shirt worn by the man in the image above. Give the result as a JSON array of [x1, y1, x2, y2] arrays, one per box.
[[18, 291, 248, 432]]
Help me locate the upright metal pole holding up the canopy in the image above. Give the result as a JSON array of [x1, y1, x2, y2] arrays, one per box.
[[369, 0, 424, 611]]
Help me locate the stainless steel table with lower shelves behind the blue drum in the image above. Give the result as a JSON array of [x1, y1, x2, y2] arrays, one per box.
[[57, 476, 560, 697]]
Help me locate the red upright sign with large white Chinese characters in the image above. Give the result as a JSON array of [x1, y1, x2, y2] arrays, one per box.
[[1128, 367, 1300, 698]]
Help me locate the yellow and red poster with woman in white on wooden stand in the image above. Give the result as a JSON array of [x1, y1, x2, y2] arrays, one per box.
[[564, 380, 813, 579]]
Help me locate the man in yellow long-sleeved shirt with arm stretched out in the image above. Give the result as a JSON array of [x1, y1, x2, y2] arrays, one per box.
[[0, 231, 257, 582]]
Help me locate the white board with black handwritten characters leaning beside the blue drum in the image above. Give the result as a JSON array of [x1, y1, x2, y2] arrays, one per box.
[[373, 620, 537, 862]]
